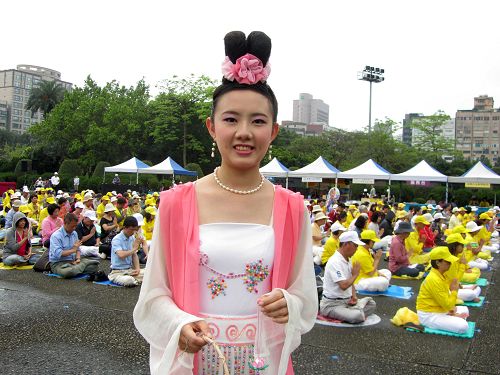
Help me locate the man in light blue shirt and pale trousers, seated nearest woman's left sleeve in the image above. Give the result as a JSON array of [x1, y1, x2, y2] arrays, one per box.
[[108, 216, 144, 287]]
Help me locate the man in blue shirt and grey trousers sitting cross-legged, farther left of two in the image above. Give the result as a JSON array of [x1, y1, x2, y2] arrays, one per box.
[[49, 213, 99, 279]]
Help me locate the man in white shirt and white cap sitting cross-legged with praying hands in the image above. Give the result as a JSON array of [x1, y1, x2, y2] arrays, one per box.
[[319, 231, 377, 324]]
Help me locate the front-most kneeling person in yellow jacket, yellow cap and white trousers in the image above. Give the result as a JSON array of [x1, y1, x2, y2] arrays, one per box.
[[417, 246, 469, 333]]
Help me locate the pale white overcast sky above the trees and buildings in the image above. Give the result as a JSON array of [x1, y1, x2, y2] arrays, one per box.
[[0, 0, 500, 130]]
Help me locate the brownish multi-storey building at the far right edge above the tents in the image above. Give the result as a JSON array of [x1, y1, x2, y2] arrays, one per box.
[[455, 95, 500, 164]]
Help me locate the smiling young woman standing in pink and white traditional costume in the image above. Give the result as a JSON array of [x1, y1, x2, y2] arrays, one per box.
[[134, 32, 318, 375]]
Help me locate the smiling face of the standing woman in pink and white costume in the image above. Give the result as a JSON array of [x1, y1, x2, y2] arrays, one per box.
[[206, 90, 278, 169]]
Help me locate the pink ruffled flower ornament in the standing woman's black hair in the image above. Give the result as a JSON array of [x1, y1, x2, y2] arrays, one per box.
[[222, 53, 271, 85]]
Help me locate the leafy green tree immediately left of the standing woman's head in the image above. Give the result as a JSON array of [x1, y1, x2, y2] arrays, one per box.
[[148, 75, 216, 166]]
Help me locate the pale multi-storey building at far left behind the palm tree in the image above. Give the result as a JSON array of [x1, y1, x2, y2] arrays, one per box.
[[0, 65, 73, 134]]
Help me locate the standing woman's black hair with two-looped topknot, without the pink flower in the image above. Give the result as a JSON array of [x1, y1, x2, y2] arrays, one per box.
[[211, 31, 278, 123]]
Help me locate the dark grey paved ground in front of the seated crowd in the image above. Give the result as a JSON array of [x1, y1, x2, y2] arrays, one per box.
[[0, 255, 500, 375]]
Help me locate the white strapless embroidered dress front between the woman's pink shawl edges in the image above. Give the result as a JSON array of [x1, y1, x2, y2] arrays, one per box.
[[198, 223, 274, 375]]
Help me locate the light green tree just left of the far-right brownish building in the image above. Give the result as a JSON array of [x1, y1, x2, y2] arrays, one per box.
[[411, 111, 454, 162]]
